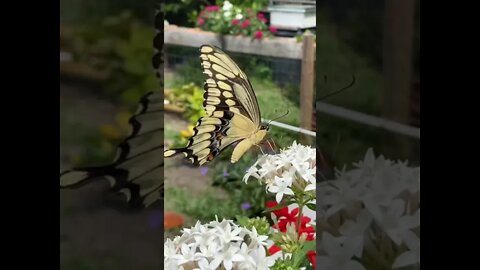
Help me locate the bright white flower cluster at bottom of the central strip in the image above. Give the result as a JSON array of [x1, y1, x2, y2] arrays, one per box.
[[164, 219, 275, 270]]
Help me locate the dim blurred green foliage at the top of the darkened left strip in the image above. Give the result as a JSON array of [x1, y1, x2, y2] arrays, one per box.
[[69, 11, 158, 107]]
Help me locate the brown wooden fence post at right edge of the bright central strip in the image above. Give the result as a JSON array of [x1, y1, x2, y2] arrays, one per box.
[[300, 32, 315, 144]]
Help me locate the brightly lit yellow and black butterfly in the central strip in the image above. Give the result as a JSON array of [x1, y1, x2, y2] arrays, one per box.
[[164, 45, 266, 166]]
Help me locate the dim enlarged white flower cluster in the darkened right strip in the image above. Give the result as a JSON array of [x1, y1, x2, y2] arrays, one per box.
[[317, 149, 420, 269]]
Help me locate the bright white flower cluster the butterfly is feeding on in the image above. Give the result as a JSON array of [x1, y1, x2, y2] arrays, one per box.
[[243, 142, 316, 203]]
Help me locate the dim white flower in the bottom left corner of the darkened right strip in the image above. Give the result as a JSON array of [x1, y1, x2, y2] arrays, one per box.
[[317, 233, 365, 270]]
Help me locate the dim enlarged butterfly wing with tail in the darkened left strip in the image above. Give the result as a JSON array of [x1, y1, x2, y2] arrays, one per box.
[[60, 7, 164, 208]]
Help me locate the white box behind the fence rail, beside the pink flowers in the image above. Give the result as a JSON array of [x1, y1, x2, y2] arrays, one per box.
[[268, 5, 317, 30]]
